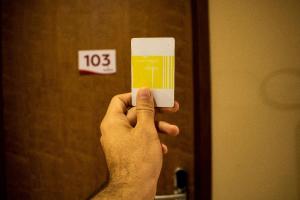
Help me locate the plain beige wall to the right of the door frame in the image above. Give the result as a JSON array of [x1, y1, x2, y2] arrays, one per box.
[[209, 0, 300, 200]]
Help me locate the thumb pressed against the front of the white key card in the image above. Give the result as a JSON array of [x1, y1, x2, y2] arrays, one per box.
[[136, 88, 154, 125]]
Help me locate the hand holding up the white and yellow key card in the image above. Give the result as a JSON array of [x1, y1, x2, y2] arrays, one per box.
[[93, 89, 179, 199]]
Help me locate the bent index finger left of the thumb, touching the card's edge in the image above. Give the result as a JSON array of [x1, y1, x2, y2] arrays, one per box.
[[107, 93, 131, 114]]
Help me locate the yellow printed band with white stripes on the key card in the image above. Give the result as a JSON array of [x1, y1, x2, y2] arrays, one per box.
[[131, 56, 175, 89]]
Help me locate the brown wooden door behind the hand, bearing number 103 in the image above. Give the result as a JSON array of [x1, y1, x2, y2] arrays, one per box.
[[1, 0, 194, 199]]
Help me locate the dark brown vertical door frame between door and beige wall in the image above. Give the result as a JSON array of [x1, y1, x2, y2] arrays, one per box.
[[191, 0, 212, 200]]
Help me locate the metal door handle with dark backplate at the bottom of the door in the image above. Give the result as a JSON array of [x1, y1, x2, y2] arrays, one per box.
[[155, 167, 187, 200]]
